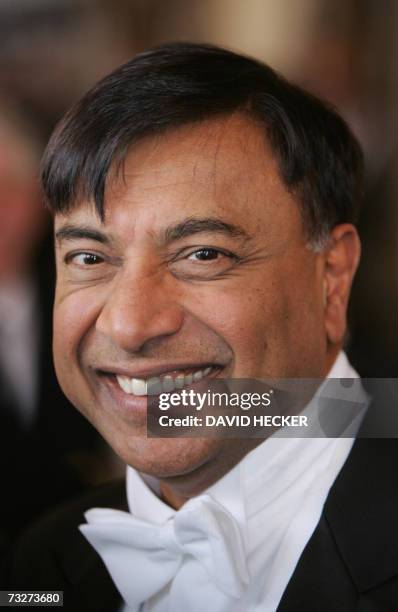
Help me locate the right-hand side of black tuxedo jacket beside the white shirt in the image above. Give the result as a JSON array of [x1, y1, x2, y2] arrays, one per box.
[[278, 439, 398, 612]]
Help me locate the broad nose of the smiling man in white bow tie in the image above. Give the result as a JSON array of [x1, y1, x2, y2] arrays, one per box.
[[96, 266, 184, 352]]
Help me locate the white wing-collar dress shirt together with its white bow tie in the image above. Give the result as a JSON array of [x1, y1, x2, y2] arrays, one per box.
[[80, 353, 364, 612]]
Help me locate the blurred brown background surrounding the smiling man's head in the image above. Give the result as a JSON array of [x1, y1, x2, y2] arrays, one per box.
[[0, 0, 398, 549]]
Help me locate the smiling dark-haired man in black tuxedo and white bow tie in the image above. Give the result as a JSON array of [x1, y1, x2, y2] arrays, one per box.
[[6, 44, 398, 612]]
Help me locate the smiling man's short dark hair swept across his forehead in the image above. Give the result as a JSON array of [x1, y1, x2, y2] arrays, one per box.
[[42, 43, 363, 243]]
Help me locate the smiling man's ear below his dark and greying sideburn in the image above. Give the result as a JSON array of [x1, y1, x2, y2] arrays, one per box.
[[323, 223, 361, 344]]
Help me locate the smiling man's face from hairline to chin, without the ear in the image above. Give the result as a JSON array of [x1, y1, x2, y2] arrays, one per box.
[[54, 116, 328, 489]]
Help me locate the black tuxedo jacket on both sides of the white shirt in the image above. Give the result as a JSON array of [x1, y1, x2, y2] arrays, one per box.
[[1, 439, 398, 612]]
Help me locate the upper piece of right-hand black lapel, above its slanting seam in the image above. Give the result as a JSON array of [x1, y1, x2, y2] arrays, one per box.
[[325, 439, 398, 592]]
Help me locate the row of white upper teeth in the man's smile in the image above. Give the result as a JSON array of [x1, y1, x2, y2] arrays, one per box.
[[116, 367, 212, 396]]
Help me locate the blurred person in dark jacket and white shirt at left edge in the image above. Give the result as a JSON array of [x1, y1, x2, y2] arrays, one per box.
[[0, 99, 110, 550]]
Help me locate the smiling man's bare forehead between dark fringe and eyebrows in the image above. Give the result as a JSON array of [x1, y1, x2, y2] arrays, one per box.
[[53, 115, 300, 239]]
